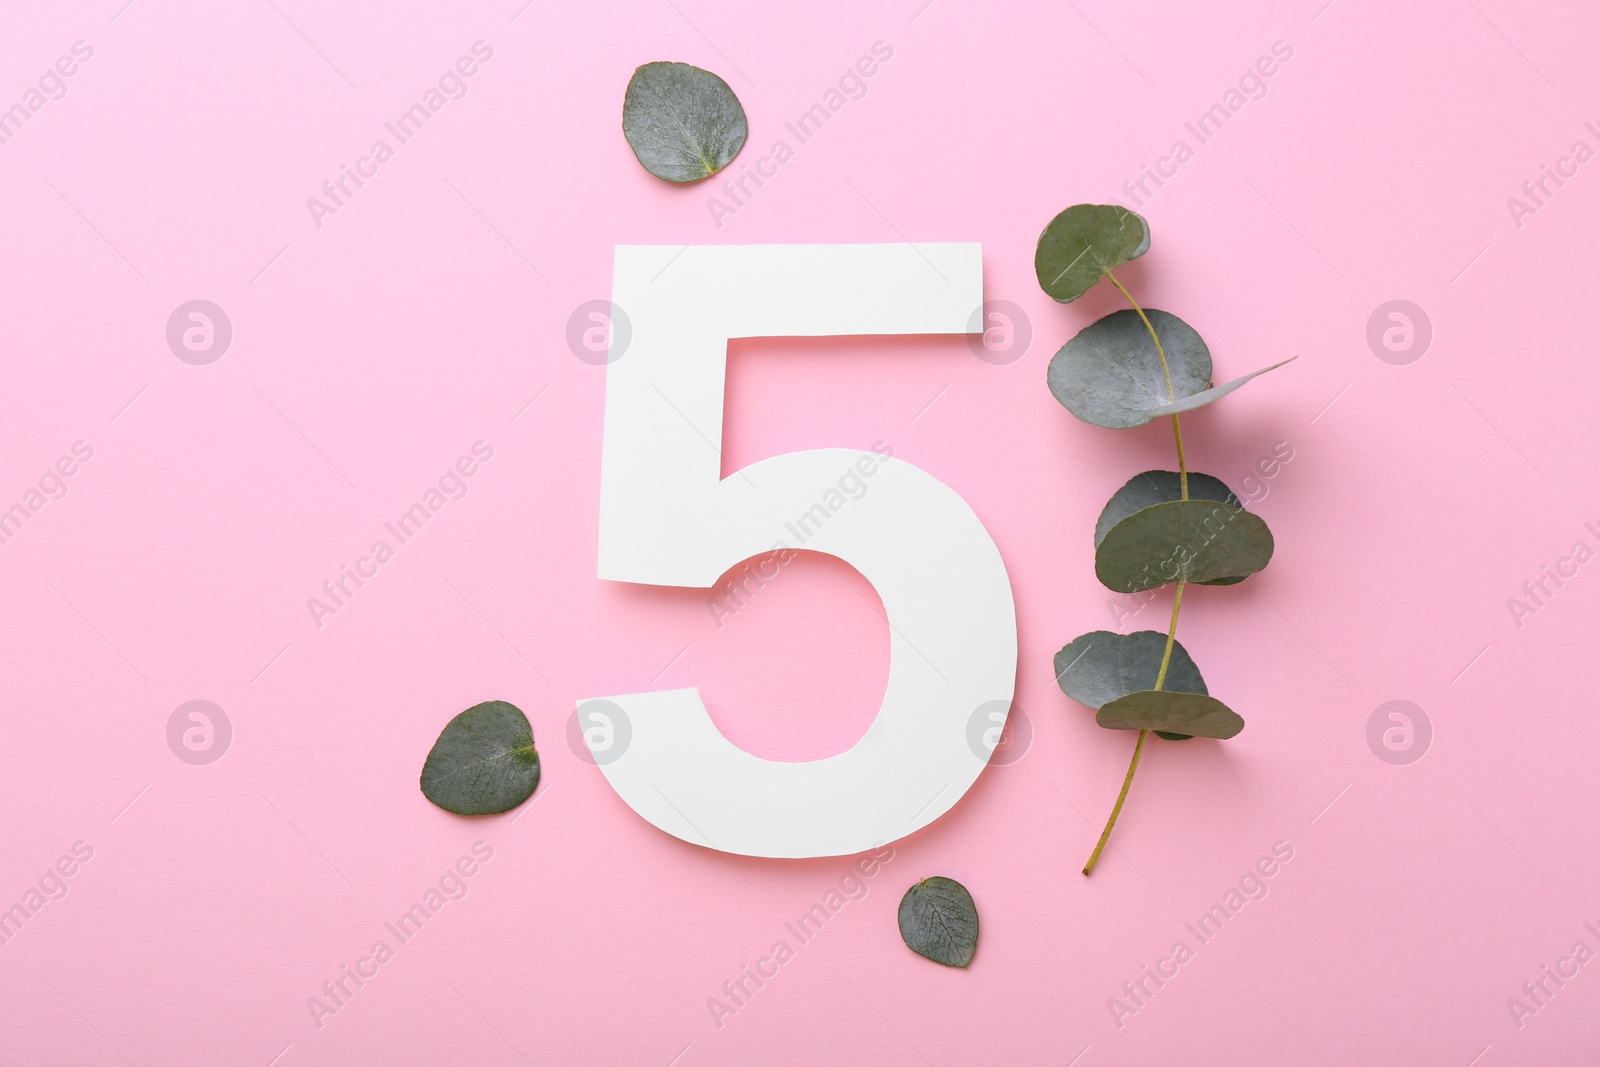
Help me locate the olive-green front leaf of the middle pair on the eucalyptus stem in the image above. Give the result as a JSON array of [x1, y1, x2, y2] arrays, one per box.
[[1094, 499, 1272, 593]]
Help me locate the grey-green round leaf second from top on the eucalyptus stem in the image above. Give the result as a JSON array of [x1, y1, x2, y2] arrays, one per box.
[[1046, 307, 1211, 430]]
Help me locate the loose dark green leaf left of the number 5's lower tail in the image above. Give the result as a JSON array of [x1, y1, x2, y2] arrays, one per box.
[[422, 701, 539, 816]]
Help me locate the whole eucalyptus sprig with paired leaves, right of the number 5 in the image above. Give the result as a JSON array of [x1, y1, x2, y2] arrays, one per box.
[[1034, 203, 1288, 873]]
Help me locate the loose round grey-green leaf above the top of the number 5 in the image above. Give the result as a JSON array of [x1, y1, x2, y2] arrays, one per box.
[[622, 62, 749, 182]]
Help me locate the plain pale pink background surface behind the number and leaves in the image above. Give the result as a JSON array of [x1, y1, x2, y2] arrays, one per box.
[[0, 0, 1600, 1067]]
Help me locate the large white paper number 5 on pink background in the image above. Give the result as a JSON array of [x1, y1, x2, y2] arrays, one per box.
[[579, 245, 1016, 857]]
